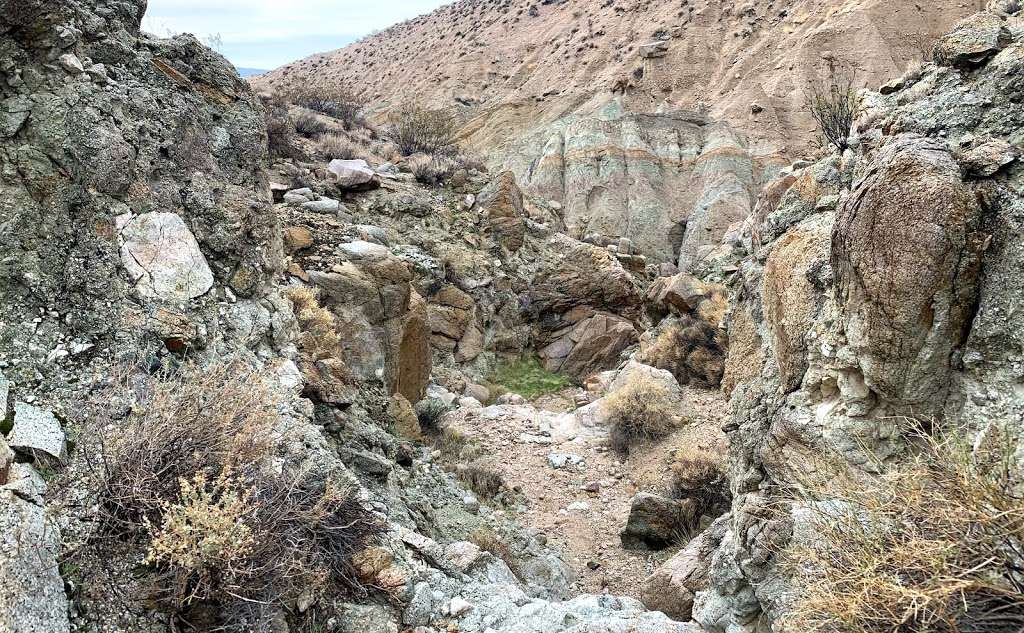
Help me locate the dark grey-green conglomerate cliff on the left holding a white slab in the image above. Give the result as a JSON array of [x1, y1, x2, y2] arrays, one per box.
[[0, 0, 281, 378]]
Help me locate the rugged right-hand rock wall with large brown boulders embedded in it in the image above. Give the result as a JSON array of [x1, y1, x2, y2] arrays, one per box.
[[688, 14, 1024, 633]]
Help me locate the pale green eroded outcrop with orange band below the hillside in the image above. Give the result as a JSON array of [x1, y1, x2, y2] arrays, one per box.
[[499, 100, 760, 269]]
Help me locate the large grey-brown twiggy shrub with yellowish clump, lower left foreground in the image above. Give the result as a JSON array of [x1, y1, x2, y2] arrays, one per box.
[[92, 361, 382, 631]]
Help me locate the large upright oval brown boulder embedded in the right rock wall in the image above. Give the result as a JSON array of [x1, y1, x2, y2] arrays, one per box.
[[831, 137, 985, 413]]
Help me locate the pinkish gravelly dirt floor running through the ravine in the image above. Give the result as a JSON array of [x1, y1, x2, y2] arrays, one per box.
[[450, 388, 728, 597]]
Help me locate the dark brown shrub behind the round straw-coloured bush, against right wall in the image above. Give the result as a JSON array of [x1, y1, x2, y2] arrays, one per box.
[[640, 314, 727, 388]]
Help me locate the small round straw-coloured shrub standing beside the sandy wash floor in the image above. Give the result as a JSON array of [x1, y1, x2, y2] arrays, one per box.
[[604, 372, 678, 456]]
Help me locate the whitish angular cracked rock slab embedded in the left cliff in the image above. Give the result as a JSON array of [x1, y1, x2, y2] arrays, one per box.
[[121, 212, 213, 302]]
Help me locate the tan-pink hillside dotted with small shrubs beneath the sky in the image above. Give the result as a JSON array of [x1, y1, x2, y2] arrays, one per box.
[[254, 0, 984, 156]]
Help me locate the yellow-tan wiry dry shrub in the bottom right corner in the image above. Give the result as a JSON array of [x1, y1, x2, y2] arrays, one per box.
[[782, 422, 1024, 633]]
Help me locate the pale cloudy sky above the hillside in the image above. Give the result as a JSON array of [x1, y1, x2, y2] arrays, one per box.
[[142, 0, 451, 70]]
